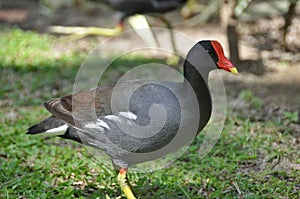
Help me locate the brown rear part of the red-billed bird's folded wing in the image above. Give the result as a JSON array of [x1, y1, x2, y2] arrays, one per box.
[[44, 86, 113, 126]]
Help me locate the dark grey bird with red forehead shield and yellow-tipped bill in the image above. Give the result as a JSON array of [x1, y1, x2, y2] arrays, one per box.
[[27, 40, 238, 199]]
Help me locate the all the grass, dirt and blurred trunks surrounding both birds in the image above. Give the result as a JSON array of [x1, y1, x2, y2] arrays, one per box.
[[0, 0, 300, 198]]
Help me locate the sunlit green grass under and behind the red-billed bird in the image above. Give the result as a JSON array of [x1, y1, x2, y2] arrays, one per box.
[[0, 29, 300, 198]]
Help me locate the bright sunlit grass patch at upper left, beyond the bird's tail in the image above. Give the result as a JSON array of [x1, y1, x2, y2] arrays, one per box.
[[0, 27, 86, 71]]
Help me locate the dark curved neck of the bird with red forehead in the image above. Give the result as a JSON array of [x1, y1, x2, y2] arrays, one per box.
[[184, 52, 212, 133]]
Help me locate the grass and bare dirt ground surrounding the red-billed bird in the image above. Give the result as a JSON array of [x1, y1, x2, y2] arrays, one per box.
[[0, 1, 300, 198]]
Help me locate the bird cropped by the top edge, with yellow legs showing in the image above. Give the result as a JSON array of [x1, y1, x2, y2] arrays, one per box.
[[49, 0, 190, 52]]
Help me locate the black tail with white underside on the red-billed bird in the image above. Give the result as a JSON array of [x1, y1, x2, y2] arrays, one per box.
[[26, 116, 65, 134]]
